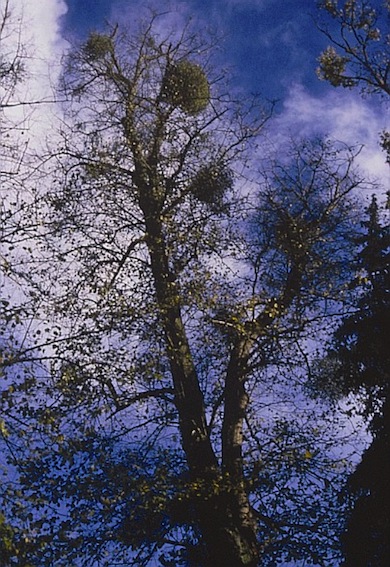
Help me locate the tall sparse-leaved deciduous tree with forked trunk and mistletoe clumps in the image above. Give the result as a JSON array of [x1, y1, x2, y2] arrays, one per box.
[[0, 15, 361, 567]]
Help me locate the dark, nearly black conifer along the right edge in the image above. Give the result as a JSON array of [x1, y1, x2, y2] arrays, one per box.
[[316, 197, 390, 567]]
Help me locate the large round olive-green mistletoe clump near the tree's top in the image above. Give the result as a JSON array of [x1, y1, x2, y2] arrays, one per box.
[[162, 60, 210, 115]]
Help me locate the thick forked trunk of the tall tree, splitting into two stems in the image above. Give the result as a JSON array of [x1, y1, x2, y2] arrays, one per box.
[[140, 183, 258, 567]]
